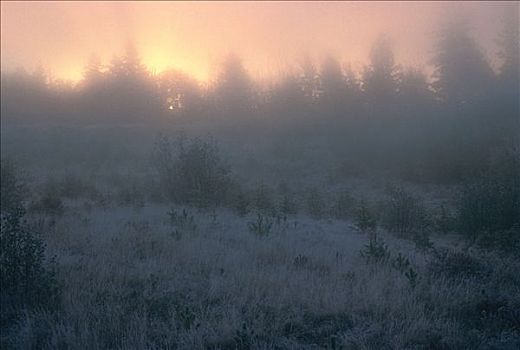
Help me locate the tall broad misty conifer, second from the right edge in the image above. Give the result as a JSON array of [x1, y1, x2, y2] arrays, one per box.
[[426, 18, 501, 180]]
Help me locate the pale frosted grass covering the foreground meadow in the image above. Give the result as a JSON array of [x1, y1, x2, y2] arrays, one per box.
[[2, 202, 520, 349]]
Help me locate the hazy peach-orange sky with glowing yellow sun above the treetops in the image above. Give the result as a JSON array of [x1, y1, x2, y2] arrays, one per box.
[[0, 1, 518, 81]]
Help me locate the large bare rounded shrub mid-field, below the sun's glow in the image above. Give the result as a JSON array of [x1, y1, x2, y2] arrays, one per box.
[[153, 137, 232, 207]]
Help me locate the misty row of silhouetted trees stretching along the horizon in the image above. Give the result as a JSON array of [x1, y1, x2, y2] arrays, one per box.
[[1, 14, 520, 182]]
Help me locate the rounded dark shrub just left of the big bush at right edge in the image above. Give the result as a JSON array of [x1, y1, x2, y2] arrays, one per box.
[[382, 186, 429, 236]]
